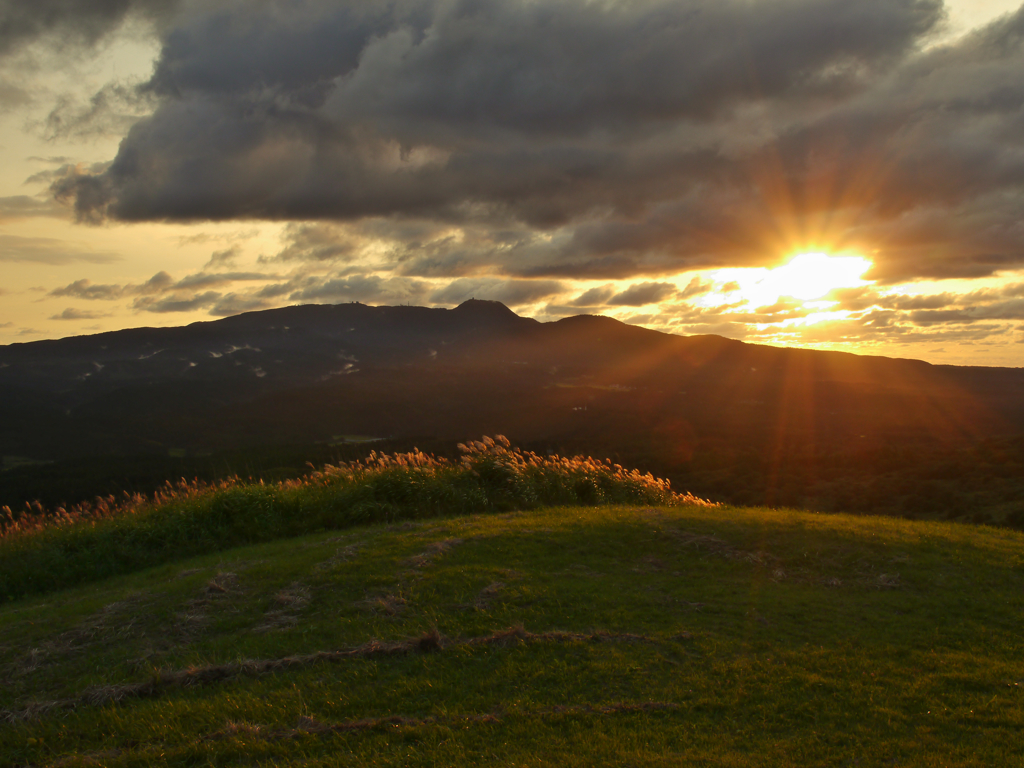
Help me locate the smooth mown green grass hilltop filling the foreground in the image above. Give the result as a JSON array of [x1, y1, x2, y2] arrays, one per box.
[[0, 506, 1024, 768]]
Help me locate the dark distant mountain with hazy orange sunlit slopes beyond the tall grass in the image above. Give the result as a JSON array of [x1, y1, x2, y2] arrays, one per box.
[[0, 301, 1024, 526]]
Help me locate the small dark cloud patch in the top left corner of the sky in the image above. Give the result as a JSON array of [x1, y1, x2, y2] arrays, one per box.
[[0, 0, 179, 56]]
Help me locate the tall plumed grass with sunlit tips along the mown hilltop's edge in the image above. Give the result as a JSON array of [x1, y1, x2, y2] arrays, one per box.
[[0, 435, 714, 601]]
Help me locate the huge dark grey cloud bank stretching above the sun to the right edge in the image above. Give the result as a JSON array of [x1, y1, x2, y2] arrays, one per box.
[[53, 0, 1024, 286]]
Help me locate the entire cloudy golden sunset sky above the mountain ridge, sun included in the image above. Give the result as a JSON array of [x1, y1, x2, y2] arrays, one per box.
[[0, 0, 1024, 367]]
